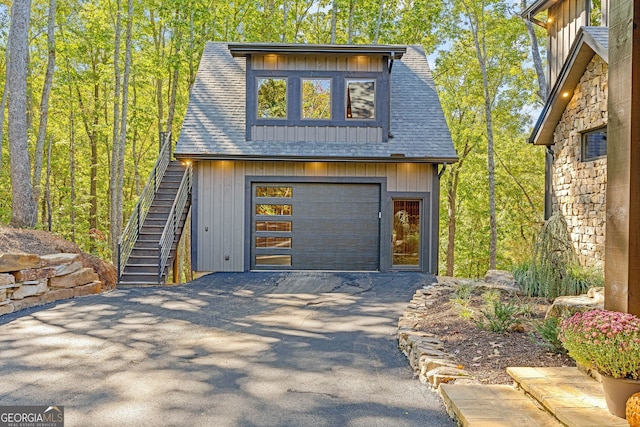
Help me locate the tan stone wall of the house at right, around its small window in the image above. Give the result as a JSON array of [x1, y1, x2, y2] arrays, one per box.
[[552, 55, 608, 269]]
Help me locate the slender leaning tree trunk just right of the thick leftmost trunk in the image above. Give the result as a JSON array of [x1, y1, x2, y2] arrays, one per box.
[[32, 0, 56, 206]]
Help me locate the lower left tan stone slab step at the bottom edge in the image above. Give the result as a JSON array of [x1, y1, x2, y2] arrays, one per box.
[[440, 384, 562, 427]]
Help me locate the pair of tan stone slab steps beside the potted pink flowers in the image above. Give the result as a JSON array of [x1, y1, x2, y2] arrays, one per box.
[[439, 367, 629, 427]]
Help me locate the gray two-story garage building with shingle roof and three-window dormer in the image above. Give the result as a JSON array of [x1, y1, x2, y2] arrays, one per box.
[[175, 43, 457, 273]]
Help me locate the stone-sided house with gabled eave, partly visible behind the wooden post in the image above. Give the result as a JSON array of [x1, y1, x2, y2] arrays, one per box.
[[523, 0, 609, 268]]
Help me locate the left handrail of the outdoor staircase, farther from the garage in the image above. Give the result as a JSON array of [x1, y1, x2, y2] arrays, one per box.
[[118, 132, 171, 283]]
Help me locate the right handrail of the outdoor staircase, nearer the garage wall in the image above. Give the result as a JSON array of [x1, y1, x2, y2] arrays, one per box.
[[158, 163, 193, 283]]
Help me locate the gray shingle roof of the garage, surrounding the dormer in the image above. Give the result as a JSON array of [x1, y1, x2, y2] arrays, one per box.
[[175, 42, 457, 162]]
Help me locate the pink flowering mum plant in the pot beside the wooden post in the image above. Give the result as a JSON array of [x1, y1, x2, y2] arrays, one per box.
[[559, 309, 640, 380]]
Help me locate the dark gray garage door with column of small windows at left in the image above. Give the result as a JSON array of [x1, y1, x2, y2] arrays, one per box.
[[251, 183, 380, 271]]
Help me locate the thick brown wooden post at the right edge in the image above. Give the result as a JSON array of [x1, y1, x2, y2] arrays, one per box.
[[605, 0, 640, 315]]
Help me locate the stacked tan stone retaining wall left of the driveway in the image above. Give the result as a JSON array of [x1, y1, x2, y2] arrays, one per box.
[[0, 253, 102, 315]]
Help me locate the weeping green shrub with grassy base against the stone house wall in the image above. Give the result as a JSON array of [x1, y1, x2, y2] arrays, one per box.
[[513, 212, 604, 298]]
